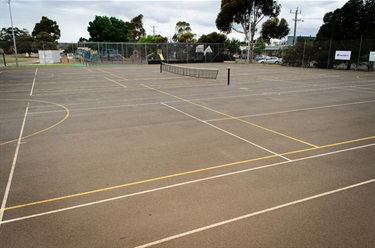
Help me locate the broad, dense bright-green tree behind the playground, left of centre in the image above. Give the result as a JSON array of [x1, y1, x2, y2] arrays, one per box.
[[87, 16, 129, 42]]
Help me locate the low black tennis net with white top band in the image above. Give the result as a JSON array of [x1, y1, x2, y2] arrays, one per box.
[[160, 62, 219, 79]]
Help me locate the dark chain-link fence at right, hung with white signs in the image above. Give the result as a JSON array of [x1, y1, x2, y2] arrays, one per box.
[[282, 38, 375, 71]]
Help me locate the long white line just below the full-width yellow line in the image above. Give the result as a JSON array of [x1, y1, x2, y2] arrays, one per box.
[[2, 143, 375, 224]]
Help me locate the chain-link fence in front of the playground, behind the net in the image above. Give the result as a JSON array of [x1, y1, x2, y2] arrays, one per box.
[[74, 42, 225, 64]]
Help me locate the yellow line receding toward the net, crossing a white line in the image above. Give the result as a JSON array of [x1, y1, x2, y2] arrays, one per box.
[[141, 84, 319, 148]]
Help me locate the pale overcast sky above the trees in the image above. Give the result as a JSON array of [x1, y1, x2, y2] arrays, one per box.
[[0, 0, 348, 42]]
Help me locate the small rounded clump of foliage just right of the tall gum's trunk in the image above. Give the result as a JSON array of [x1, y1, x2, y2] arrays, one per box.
[[260, 17, 290, 44]]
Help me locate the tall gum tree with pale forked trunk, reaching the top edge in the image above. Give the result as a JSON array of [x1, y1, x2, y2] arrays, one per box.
[[216, 0, 281, 62]]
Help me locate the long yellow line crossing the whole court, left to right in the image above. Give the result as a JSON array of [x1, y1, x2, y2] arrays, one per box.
[[4, 136, 375, 211]]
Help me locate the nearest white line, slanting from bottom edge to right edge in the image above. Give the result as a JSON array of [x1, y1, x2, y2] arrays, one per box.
[[135, 178, 375, 248]]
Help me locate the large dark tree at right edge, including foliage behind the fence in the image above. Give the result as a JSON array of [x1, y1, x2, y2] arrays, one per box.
[[314, 0, 375, 70]]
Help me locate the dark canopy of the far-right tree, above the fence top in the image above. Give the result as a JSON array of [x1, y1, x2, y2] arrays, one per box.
[[317, 0, 375, 41]]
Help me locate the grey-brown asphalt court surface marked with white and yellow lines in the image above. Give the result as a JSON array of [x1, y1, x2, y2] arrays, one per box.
[[0, 63, 375, 247]]
